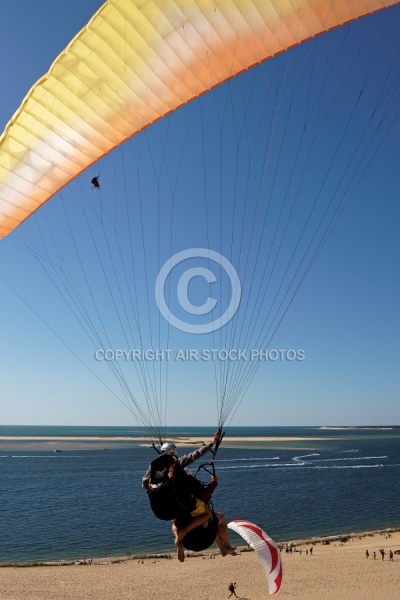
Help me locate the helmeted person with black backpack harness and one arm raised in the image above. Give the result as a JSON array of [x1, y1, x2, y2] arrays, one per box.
[[142, 431, 221, 560]]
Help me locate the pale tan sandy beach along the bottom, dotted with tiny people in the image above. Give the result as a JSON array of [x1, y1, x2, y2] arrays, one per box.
[[0, 532, 400, 600]]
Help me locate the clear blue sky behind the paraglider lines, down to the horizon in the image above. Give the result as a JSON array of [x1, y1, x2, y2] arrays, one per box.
[[0, 0, 400, 425]]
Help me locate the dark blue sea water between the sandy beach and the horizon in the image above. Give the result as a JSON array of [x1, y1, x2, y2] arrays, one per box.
[[0, 427, 400, 563]]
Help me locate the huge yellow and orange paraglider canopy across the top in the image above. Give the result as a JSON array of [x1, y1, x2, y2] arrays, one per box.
[[0, 0, 397, 238]]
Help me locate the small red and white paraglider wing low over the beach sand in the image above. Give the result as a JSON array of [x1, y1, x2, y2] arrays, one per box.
[[228, 520, 282, 594]]
